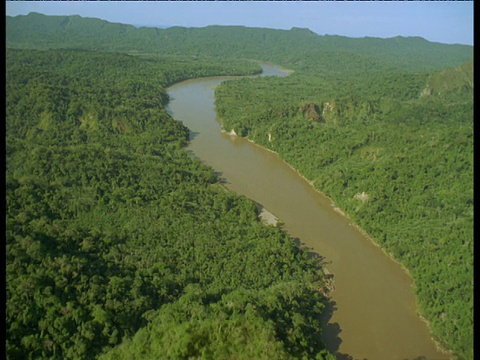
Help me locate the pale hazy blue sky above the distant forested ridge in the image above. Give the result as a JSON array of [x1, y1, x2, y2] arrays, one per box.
[[6, 1, 473, 45]]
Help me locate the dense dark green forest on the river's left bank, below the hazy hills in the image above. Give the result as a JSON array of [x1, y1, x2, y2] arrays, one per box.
[[6, 49, 334, 359]]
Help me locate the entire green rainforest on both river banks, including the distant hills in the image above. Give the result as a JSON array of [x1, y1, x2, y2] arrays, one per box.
[[5, 13, 473, 359]]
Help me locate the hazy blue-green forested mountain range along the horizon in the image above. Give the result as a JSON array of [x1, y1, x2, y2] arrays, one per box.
[[6, 12, 473, 71]]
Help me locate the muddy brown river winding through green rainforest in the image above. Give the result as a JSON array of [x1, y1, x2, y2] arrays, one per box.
[[167, 64, 449, 360]]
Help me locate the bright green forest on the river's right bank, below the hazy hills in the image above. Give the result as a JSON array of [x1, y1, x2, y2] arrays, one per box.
[[216, 62, 473, 359]]
